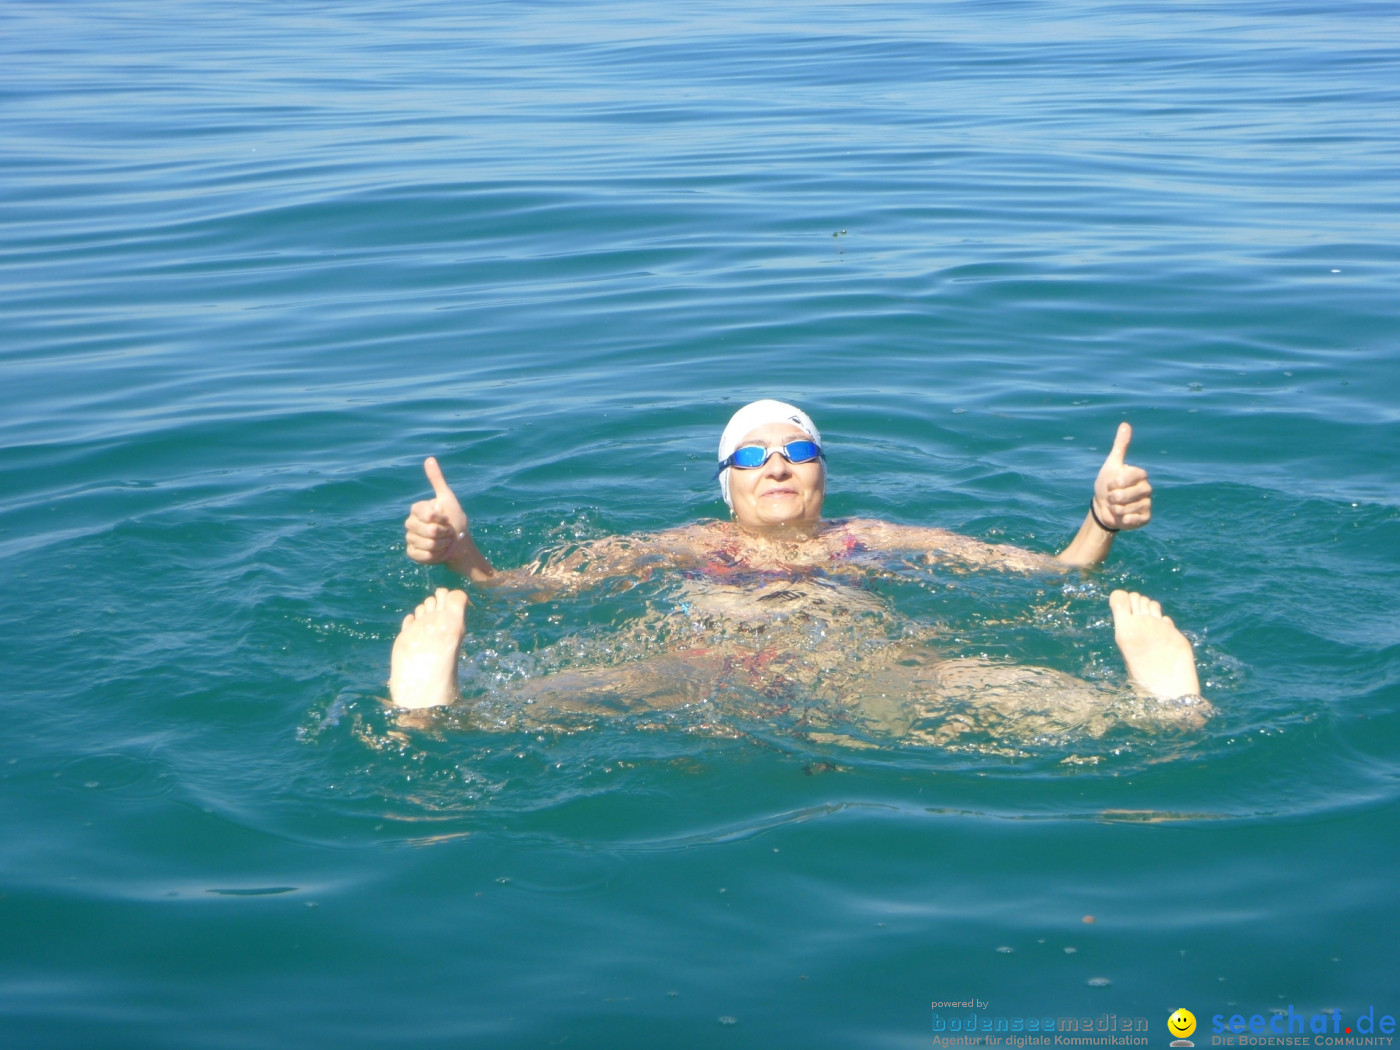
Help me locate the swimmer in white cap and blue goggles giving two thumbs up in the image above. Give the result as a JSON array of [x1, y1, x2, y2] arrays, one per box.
[[389, 400, 1211, 743]]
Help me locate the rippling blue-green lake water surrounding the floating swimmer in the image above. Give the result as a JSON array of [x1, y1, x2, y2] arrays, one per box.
[[0, 0, 1400, 1047]]
